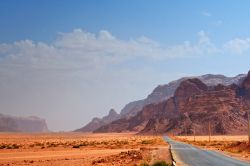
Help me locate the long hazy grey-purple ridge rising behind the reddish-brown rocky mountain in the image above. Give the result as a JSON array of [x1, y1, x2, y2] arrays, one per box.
[[76, 74, 246, 132]]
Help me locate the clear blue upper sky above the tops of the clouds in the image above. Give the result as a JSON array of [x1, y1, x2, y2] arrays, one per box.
[[0, 0, 250, 44]]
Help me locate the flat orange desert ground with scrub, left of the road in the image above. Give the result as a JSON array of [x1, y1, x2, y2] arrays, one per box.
[[0, 133, 171, 166]]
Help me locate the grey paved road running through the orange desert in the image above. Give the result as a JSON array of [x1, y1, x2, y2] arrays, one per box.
[[164, 136, 250, 166]]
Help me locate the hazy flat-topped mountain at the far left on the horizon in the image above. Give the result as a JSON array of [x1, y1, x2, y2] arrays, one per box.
[[0, 114, 49, 132]]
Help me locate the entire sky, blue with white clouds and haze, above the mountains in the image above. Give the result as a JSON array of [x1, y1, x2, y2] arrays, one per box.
[[0, 0, 250, 130]]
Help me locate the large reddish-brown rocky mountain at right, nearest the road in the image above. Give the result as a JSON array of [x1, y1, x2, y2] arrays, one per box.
[[95, 72, 250, 134]]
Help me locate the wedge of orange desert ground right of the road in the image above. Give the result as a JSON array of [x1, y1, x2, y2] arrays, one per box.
[[173, 135, 250, 161]]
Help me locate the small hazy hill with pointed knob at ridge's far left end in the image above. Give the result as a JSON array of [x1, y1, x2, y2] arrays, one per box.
[[75, 109, 120, 132]]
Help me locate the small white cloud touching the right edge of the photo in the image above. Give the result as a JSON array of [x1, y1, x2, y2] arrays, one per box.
[[224, 38, 250, 54]]
